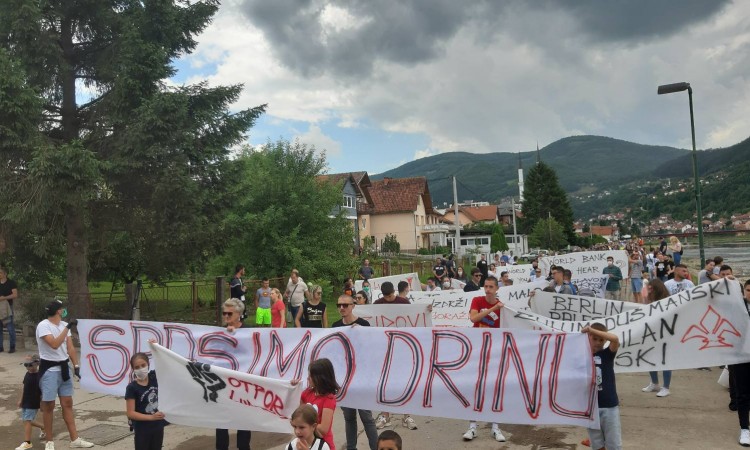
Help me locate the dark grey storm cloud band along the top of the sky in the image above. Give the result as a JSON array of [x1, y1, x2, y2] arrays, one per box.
[[242, 0, 729, 79]]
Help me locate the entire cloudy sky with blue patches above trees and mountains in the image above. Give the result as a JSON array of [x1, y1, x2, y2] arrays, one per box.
[[175, 0, 750, 173]]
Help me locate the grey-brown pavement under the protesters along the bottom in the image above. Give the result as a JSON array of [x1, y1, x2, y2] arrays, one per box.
[[0, 338, 739, 450]]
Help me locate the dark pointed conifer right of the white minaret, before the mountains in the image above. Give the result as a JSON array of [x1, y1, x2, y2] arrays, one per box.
[[521, 162, 575, 242]]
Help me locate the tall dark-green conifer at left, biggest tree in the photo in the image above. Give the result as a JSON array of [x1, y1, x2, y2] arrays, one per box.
[[0, 0, 264, 315]]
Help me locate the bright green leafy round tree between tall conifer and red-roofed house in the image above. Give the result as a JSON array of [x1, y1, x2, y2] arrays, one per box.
[[217, 140, 356, 282]]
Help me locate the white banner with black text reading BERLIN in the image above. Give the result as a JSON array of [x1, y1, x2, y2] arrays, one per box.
[[531, 291, 643, 322]]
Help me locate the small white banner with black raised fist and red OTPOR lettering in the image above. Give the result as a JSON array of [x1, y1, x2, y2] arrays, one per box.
[[151, 344, 303, 433]]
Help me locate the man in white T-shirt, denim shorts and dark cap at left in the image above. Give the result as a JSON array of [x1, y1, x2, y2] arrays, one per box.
[[36, 300, 94, 450]]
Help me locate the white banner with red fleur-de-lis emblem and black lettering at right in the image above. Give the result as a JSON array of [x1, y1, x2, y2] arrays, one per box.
[[500, 278, 750, 372]]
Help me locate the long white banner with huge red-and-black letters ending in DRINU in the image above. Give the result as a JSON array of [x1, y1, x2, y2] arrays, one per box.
[[79, 320, 598, 429]]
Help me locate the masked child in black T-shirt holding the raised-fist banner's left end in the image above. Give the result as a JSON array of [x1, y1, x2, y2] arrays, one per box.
[[125, 352, 167, 450]]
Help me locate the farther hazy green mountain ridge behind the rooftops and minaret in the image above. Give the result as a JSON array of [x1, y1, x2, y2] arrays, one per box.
[[371, 136, 689, 205]]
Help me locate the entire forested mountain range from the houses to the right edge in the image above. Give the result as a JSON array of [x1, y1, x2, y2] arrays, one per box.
[[371, 136, 750, 220]]
